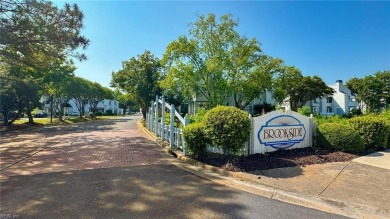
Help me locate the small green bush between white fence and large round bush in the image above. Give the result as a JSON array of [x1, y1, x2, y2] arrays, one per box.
[[183, 123, 211, 157]]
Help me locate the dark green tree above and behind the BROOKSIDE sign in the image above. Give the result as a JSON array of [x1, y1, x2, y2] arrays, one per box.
[[273, 66, 334, 111]]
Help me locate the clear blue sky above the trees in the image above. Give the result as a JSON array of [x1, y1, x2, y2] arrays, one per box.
[[55, 0, 390, 87]]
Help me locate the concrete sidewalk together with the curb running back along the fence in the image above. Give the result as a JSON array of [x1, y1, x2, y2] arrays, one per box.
[[139, 122, 390, 218]]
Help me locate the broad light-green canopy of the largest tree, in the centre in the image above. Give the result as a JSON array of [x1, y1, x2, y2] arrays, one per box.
[[161, 14, 281, 108]]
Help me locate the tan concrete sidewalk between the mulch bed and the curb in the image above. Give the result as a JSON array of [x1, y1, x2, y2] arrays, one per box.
[[250, 150, 390, 218]]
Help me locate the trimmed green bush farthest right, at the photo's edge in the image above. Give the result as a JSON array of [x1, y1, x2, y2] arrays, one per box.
[[349, 116, 390, 150]]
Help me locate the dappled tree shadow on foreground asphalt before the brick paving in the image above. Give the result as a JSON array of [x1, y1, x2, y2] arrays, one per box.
[[1, 165, 245, 218]]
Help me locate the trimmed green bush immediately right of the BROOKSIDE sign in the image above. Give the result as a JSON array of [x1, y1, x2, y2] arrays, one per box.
[[316, 123, 364, 153]]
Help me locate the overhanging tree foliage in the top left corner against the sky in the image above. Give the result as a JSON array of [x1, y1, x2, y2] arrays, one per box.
[[0, 0, 89, 67]]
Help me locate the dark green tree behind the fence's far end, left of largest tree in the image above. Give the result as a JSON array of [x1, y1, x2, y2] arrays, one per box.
[[111, 50, 161, 118]]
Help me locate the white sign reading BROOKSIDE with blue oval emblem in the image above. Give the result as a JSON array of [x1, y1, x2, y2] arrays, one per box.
[[249, 111, 313, 154]]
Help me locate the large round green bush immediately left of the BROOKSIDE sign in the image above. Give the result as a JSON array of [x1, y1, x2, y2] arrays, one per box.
[[203, 106, 251, 154]]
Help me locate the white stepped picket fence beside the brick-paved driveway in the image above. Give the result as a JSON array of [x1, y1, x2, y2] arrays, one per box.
[[146, 96, 188, 155]]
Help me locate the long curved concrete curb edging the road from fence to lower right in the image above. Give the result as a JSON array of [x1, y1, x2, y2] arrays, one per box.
[[137, 120, 390, 219]]
